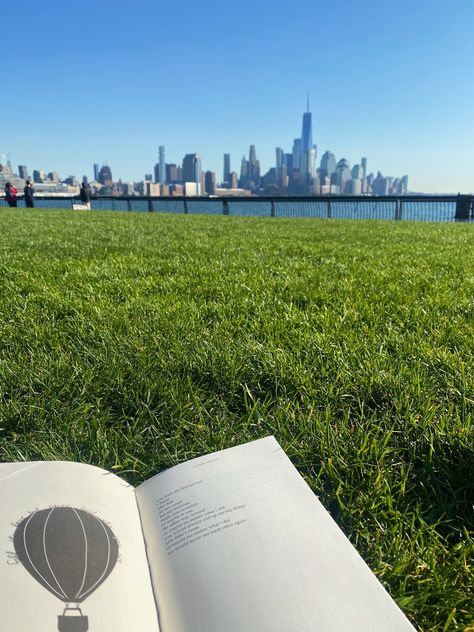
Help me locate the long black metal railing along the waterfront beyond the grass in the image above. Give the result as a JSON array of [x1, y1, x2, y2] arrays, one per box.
[[0, 195, 474, 222]]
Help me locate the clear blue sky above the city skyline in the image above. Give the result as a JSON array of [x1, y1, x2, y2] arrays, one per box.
[[0, 0, 474, 192]]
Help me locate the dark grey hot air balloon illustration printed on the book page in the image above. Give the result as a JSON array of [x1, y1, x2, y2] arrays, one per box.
[[13, 507, 118, 632]]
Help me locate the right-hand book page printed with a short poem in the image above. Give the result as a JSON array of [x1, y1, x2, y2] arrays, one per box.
[[136, 437, 414, 632]]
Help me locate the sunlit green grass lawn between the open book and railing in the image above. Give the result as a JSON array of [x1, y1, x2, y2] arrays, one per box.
[[0, 209, 474, 631]]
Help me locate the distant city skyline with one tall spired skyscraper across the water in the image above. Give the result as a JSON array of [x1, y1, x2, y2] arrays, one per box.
[[0, 103, 410, 196]]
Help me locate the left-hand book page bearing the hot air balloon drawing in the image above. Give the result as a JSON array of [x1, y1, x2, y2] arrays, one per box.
[[0, 462, 159, 632]]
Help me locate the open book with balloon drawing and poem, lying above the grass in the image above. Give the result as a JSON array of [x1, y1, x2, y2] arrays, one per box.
[[0, 437, 414, 632]]
